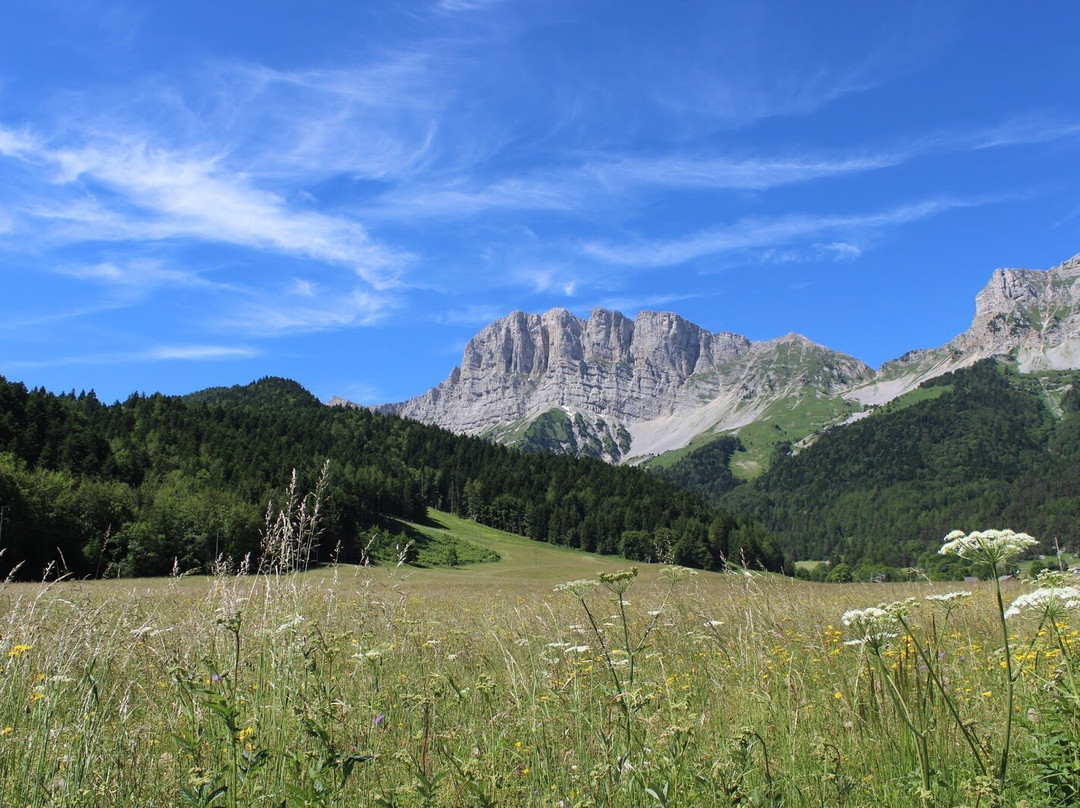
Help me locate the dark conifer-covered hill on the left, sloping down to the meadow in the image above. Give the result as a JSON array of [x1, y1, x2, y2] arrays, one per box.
[[0, 377, 783, 577]]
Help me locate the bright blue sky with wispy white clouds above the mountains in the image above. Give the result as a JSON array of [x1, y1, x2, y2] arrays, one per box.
[[0, 0, 1080, 403]]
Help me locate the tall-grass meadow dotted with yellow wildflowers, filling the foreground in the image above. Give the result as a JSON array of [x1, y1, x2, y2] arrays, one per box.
[[0, 513, 1080, 807]]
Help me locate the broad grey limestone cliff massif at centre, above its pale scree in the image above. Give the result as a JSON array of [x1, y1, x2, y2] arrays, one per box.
[[382, 309, 873, 459]]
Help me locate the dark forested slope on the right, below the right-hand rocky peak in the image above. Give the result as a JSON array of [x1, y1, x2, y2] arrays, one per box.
[[698, 360, 1080, 577]]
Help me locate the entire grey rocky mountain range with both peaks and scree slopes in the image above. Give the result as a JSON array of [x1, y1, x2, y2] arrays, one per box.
[[369, 250, 1080, 466]]
